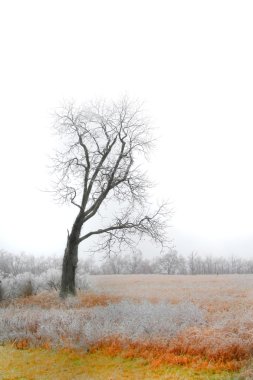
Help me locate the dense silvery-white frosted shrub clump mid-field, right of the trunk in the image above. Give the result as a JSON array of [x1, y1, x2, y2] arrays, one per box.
[[84, 301, 204, 341]]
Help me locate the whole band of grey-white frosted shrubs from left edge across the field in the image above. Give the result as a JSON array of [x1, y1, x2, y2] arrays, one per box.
[[0, 301, 204, 346]]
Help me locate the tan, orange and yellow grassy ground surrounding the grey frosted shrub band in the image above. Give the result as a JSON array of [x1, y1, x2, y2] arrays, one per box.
[[0, 275, 253, 380]]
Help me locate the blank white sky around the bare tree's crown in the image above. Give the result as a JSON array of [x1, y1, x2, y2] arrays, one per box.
[[0, 0, 253, 257]]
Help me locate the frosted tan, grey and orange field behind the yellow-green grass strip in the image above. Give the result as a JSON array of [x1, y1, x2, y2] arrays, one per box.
[[0, 275, 253, 368]]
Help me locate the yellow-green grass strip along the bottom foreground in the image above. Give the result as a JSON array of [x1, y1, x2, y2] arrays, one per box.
[[0, 345, 238, 380]]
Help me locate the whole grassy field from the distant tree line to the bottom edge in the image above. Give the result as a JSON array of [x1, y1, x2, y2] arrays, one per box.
[[0, 275, 253, 380]]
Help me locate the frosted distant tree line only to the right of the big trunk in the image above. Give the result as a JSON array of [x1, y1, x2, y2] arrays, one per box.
[[84, 250, 253, 275]]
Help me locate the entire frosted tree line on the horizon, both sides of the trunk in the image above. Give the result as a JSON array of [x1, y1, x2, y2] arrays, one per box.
[[0, 249, 253, 278]]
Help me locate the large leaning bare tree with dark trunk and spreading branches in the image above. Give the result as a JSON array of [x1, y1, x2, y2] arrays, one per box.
[[53, 98, 168, 297]]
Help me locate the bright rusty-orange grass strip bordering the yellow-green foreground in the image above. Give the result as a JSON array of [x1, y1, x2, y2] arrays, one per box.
[[12, 328, 248, 371]]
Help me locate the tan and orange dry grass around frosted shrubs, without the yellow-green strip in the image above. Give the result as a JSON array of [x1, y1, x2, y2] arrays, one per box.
[[1, 275, 253, 379]]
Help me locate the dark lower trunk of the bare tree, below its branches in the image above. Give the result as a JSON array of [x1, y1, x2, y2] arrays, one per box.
[[60, 217, 82, 298]]
